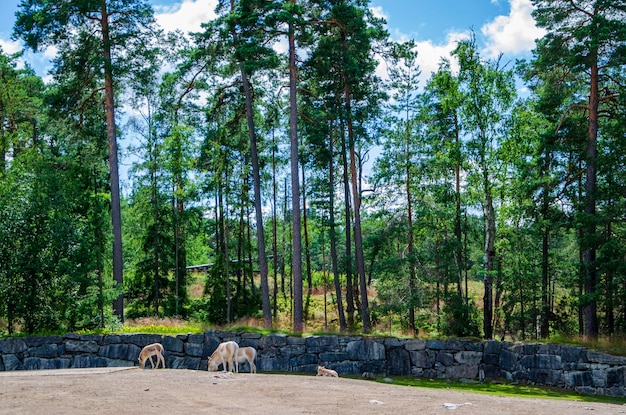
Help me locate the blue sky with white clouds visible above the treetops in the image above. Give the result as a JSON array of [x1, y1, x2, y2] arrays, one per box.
[[0, 0, 543, 85]]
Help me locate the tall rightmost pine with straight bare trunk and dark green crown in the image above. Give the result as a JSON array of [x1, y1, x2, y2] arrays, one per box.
[[533, 0, 626, 338]]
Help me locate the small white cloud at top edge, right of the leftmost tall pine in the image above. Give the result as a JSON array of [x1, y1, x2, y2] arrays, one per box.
[[155, 0, 218, 33]]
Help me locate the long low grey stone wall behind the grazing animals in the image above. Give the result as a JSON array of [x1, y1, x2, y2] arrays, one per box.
[[0, 330, 626, 397]]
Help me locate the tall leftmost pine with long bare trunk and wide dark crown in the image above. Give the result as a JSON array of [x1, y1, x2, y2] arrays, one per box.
[[14, 0, 153, 322]]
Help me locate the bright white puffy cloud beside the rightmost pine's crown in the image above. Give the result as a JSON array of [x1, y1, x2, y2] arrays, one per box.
[[481, 0, 545, 58]]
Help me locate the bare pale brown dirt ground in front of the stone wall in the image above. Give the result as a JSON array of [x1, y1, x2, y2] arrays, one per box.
[[0, 368, 626, 415]]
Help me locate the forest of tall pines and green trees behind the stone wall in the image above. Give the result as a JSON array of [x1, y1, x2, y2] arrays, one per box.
[[0, 0, 626, 339]]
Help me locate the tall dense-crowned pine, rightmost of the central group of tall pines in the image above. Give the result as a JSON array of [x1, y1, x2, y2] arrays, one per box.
[[310, 0, 387, 333]]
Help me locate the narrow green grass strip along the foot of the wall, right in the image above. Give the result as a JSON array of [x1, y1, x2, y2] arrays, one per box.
[[377, 376, 626, 405]]
